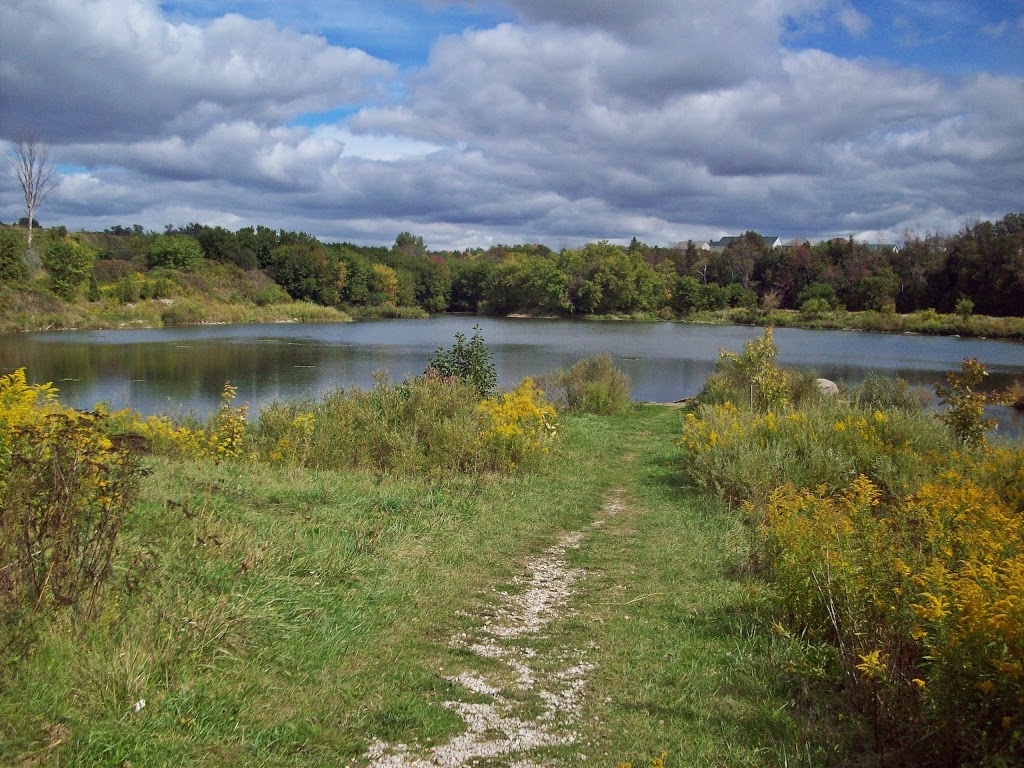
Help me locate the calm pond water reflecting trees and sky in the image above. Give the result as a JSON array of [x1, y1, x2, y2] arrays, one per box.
[[0, 315, 1024, 435]]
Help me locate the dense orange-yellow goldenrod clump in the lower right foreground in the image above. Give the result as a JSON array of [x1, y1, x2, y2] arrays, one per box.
[[764, 472, 1024, 764]]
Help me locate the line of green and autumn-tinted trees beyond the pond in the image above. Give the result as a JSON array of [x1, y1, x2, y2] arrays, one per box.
[[0, 213, 1024, 316]]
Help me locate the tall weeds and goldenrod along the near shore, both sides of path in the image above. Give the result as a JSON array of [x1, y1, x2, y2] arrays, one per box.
[[0, 328, 1024, 765]]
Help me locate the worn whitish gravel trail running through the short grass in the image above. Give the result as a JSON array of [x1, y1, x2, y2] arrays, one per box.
[[365, 492, 624, 768]]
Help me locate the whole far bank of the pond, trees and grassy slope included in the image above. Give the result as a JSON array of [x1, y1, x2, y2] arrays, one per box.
[[0, 214, 1024, 339]]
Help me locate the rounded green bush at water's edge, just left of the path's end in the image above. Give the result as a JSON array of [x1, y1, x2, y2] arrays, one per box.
[[541, 354, 630, 415]]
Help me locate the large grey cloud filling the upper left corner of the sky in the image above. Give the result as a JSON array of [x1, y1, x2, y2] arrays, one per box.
[[0, 0, 395, 141]]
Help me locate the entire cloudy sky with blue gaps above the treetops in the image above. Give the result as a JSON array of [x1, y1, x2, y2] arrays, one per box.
[[0, 0, 1024, 250]]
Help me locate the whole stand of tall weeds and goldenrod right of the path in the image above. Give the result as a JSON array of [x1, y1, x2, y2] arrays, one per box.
[[680, 329, 1024, 765]]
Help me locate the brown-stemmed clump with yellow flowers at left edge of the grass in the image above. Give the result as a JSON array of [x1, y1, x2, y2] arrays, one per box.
[[0, 369, 140, 656]]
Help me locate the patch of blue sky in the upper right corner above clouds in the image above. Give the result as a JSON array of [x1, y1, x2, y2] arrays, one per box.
[[782, 0, 1024, 76]]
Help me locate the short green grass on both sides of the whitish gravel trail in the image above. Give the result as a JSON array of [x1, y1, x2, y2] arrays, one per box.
[[0, 407, 831, 768]]
